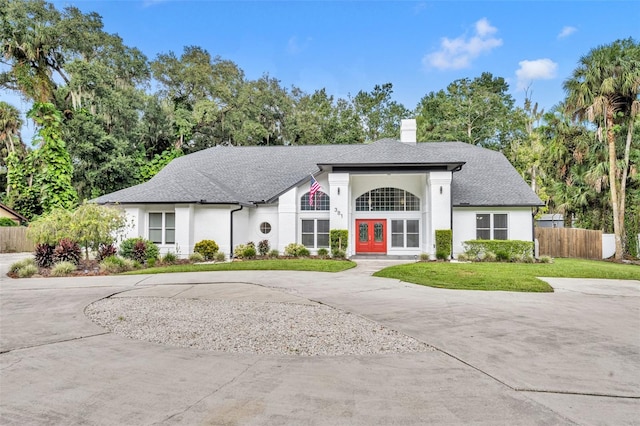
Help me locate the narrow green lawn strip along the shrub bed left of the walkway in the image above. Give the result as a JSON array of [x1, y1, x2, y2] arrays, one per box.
[[125, 259, 356, 275]]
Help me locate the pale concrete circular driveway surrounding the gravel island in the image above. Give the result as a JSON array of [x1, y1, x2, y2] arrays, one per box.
[[0, 255, 640, 425]]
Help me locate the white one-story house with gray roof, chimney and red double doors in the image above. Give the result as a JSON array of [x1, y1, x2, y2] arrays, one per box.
[[94, 120, 542, 257]]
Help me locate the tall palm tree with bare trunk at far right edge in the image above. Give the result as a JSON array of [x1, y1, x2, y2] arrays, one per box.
[[564, 38, 640, 260]]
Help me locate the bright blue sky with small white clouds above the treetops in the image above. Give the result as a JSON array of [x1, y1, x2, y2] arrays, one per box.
[[3, 0, 640, 143]]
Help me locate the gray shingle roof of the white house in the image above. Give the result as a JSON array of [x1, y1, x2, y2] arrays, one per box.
[[94, 139, 541, 206]]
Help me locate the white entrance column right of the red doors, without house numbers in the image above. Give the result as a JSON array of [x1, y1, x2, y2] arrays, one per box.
[[427, 172, 451, 255]]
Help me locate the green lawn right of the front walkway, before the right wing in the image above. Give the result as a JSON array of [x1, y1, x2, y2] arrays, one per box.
[[374, 259, 640, 292]]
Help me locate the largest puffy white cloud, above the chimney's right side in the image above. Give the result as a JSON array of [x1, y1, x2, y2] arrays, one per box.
[[422, 18, 502, 70]]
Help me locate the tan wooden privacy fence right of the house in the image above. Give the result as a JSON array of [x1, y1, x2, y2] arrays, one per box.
[[535, 228, 602, 259]]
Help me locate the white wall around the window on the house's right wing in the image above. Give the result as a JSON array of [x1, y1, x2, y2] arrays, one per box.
[[453, 207, 533, 257]]
